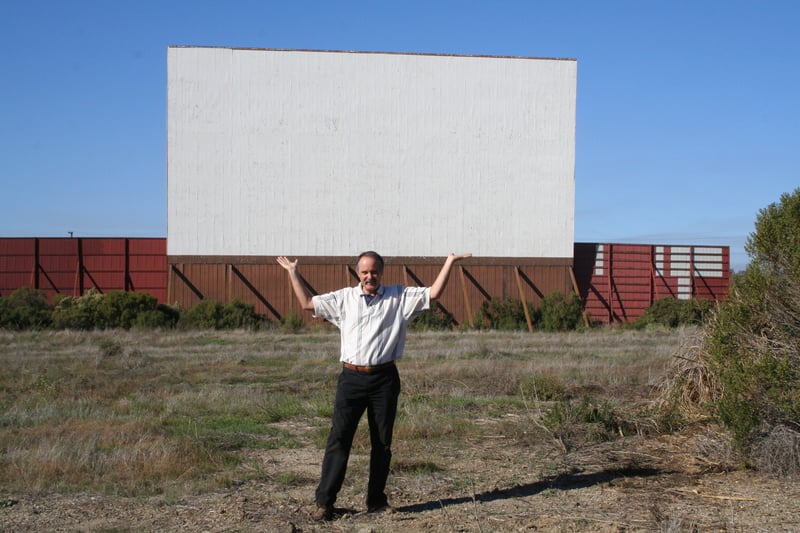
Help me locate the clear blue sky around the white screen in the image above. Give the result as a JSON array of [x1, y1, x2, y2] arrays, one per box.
[[0, 0, 800, 270]]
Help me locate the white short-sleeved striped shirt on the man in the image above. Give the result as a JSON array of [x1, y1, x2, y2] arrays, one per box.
[[311, 285, 431, 366]]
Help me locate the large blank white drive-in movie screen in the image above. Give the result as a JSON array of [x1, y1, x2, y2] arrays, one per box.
[[167, 47, 577, 258]]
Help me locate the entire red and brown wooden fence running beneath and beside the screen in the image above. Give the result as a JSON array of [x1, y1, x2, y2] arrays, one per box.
[[0, 238, 731, 329]]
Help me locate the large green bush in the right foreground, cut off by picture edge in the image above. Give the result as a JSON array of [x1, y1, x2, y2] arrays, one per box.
[[664, 189, 800, 465]]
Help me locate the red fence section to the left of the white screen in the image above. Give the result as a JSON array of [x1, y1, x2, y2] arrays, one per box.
[[0, 238, 167, 302]]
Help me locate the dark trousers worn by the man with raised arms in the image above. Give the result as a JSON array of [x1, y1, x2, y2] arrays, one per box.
[[316, 365, 400, 507]]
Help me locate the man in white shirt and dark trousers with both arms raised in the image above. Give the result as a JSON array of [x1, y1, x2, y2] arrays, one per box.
[[278, 252, 472, 520]]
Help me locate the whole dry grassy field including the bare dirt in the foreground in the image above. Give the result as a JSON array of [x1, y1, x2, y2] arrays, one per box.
[[0, 329, 800, 532]]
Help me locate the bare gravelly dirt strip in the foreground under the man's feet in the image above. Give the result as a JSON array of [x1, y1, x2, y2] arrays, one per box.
[[0, 424, 800, 532]]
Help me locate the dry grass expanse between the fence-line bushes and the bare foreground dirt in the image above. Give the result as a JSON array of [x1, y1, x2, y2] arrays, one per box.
[[0, 330, 687, 495]]
